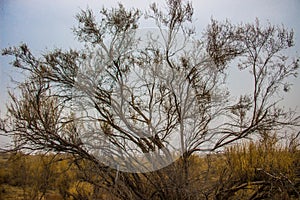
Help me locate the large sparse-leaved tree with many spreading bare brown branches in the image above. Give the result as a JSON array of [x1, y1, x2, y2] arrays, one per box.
[[1, 0, 299, 199]]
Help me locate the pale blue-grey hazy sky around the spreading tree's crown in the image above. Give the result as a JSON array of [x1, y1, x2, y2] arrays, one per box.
[[0, 0, 300, 144]]
